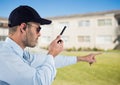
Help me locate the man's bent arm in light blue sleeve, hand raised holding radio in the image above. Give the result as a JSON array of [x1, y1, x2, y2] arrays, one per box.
[[26, 36, 63, 85]]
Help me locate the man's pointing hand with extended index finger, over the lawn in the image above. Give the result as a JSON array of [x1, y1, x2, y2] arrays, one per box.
[[77, 53, 101, 65]]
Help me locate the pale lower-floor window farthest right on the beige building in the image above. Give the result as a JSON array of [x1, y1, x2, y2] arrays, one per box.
[[96, 35, 112, 44]]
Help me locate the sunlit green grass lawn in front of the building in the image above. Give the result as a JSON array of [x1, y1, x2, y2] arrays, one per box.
[[52, 51, 120, 85]]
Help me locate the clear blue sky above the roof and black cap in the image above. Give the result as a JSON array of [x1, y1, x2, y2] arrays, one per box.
[[0, 0, 120, 18]]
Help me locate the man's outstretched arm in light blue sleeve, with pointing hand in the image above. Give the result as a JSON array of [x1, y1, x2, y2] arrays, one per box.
[[55, 53, 101, 68]]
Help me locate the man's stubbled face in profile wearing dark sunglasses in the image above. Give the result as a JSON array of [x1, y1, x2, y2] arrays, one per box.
[[24, 22, 41, 47]]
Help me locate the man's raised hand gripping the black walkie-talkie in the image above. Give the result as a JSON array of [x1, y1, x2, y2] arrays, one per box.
[[48, 35, 63, 57]]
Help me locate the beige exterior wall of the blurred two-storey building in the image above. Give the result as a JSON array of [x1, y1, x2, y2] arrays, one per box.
[[0, 11, 120, 50]]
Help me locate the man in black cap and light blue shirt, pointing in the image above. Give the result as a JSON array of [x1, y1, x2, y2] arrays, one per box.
[[0, 6, 97, 85]]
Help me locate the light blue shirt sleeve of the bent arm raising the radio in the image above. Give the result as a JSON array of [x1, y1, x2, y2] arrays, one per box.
[[35, 55, 56, 85]]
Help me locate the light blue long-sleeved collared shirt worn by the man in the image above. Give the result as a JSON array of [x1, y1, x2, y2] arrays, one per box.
[[0, 38, 77, 85]]
